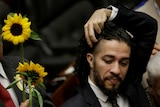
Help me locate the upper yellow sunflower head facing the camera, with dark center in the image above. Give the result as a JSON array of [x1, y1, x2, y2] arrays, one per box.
[[2, 13, 31, 45]]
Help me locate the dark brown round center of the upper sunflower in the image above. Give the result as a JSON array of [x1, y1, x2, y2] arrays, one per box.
[[11, 23, 22, 36]]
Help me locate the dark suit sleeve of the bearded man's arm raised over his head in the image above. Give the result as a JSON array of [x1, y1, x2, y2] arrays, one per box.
[[113, 4, 157, 81]]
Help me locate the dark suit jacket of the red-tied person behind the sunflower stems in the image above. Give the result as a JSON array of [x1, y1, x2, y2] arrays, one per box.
[[0, 56, 54, 107]]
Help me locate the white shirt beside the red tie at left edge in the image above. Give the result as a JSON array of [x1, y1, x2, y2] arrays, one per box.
[[0, 63, 19, 107]]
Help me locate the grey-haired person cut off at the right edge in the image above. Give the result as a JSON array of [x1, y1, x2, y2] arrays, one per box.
[[146, 52, 160, 107]]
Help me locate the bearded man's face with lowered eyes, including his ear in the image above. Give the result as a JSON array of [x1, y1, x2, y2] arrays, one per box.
[[87, 40, 130, 95]]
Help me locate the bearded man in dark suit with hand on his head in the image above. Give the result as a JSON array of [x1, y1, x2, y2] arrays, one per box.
[[62, 4, 157, 107]]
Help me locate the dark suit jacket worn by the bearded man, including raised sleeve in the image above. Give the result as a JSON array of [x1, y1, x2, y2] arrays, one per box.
[[62, 4, 157, 107]]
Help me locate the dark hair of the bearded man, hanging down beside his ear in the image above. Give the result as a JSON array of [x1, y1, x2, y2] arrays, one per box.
[[75, 22, 132, 83]]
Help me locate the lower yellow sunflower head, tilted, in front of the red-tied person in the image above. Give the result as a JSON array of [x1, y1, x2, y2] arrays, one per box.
[[16, 61, 47, 86]]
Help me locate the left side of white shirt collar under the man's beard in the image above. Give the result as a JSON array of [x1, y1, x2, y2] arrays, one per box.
[[88, 77, 108, 102]]
